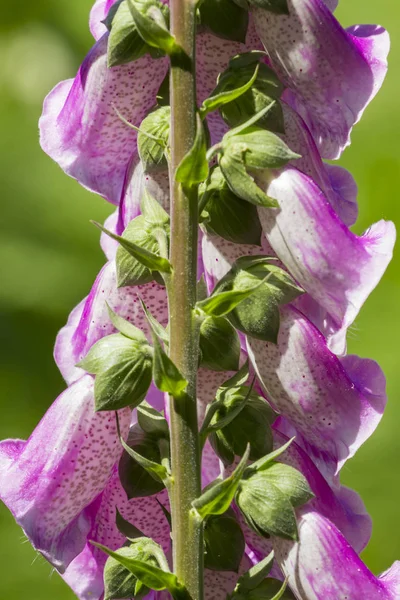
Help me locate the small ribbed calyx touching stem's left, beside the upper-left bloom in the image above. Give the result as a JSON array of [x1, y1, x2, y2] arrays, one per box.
[[137, 106, 171, 173]]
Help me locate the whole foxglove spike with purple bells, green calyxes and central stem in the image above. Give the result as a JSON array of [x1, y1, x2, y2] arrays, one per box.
[[0, 0, 400, 600]]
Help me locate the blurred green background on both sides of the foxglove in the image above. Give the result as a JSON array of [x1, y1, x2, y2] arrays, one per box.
[[0, 0, 400, 600]]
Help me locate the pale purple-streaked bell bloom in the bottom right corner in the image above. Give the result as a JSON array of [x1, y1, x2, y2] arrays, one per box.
[[274, 508, 400, 600]]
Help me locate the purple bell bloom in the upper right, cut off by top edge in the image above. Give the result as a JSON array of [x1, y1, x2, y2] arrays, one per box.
[[253, 0, 390, 159]]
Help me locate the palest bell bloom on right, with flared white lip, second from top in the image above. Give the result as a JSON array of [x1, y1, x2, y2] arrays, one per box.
[[259, 167, 396, 353]]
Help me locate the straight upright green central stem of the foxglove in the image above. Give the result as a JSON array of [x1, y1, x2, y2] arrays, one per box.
[[168, 0, 203, 600]]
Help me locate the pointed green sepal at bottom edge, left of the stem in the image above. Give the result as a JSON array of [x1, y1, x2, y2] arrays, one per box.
[[95, 538, 189, 598]]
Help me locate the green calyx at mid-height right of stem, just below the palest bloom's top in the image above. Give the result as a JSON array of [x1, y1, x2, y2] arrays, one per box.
[[214, 256, 303, 343]]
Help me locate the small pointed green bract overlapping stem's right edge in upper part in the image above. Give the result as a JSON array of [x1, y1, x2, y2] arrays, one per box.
[[175, 114, 209, 188]]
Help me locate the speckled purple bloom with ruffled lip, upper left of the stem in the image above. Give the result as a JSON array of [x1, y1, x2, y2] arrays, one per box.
[[39, 34, 168, 204]]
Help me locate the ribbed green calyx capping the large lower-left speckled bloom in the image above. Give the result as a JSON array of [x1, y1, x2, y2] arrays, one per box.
[[78, 332, 153, 411]]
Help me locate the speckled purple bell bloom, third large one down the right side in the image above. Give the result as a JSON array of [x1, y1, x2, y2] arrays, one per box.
[[247, 305, 386, 479]]
